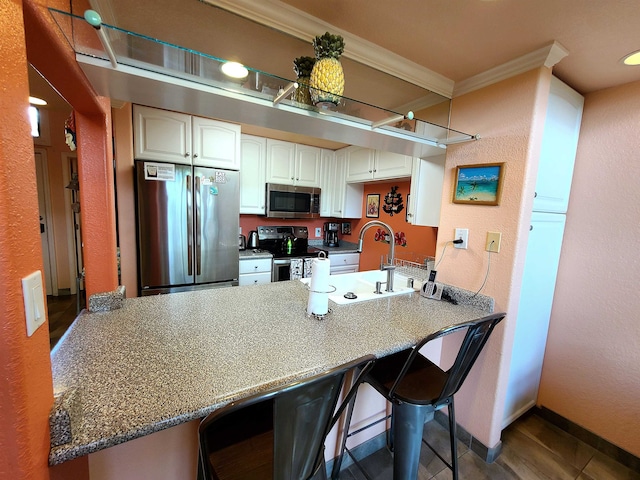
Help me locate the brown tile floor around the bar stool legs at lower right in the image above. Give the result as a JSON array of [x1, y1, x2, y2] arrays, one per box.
[[340, 414, 640, 480]]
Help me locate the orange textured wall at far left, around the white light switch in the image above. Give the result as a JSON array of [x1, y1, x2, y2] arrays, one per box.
[[0, 0, 53, 480]]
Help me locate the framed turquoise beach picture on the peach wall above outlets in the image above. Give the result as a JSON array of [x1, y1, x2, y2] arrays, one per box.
[[452, 163, 505, 205]]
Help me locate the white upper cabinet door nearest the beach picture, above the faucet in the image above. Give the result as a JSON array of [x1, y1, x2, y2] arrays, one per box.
[[407, 155, 445, 227]]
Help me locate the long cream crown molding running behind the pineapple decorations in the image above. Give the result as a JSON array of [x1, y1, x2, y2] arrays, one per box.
[[200, 0, 454, 98]]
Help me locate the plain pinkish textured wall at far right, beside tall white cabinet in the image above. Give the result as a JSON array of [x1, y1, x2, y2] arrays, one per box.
[[538, 82, 640, 456]]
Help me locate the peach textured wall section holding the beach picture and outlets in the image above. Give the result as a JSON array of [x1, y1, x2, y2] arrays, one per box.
[[436, 68, 551, 447]]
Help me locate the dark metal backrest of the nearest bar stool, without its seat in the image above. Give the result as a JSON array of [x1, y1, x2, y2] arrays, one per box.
[[199, 355, 375, 480]]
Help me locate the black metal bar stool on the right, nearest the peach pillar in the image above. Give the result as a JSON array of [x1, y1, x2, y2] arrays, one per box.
[[332, 313, 506, 480]]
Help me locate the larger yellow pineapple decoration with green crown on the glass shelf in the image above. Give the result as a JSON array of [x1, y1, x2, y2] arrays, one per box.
[[309, 32, 344, 105]]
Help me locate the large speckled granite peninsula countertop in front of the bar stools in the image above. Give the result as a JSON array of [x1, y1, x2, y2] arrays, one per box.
[[49, 281, 493, 465]]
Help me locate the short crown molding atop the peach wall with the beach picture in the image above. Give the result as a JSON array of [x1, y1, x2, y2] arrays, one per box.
[[453, 41, 569, 97]]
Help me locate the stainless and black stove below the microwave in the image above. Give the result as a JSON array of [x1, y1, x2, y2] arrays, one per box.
[[258, 226, 326, 282]]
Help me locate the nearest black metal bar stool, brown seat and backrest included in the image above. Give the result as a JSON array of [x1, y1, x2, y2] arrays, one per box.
[[199, 355, 375, 480]]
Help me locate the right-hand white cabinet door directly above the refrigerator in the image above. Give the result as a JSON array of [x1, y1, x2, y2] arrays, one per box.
[[192, 117, 240, 170]]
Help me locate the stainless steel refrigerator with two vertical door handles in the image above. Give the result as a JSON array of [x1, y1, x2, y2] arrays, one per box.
[[136, 160, 240, 295]]
